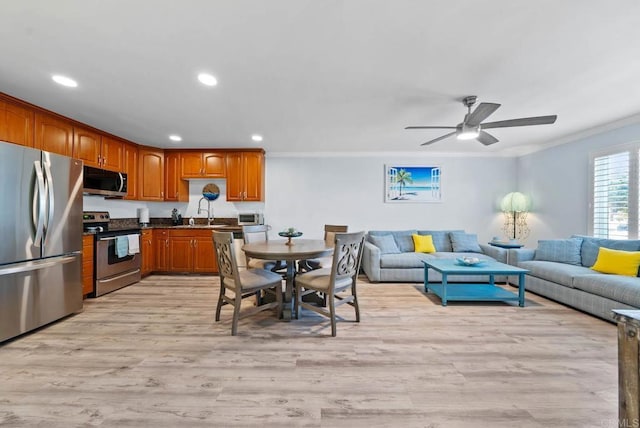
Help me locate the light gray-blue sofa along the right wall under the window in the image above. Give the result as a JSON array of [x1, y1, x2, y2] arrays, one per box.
[[509, 235, 640, 321]]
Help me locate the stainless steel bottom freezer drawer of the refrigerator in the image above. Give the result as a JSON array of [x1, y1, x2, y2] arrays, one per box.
[[0, 254, 82, 342]]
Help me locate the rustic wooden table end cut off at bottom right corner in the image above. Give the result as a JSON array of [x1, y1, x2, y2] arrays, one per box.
[[613, 309, 640, 427]]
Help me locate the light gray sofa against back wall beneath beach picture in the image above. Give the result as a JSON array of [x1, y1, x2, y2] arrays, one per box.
[[362, 229, 507, 282]]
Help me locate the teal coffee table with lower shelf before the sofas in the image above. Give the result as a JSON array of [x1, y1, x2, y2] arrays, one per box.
[[422, 259, 529, 307]]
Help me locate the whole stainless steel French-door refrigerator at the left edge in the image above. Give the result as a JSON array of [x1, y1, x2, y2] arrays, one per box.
[[0, 142, 82, 342]]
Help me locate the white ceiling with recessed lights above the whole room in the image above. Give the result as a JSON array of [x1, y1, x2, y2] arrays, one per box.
[[0, 0, 640, 155]]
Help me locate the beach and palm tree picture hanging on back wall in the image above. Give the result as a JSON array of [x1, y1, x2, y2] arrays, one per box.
[[384, 164, 442, 203]]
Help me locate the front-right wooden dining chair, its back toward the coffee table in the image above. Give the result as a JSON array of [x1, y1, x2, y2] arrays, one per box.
[[295, 232, 364, 336]]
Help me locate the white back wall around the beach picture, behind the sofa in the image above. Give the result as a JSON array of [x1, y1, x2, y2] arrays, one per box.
[[265, 154, 516, 242]]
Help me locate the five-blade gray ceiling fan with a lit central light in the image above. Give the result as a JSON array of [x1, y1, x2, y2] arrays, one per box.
[[404, 95, 558, 146]]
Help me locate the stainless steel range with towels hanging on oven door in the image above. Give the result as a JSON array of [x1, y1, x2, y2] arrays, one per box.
[[82, 211, 141, 297]]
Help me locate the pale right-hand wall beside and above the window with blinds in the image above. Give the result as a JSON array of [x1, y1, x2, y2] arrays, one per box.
[[517, 124, 640, 247]]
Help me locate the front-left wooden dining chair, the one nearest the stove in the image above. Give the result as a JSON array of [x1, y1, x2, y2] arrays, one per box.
[[213, 232, 282, 336]]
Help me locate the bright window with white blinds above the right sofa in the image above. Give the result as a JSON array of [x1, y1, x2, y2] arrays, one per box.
[[590, 145, 640, 239]]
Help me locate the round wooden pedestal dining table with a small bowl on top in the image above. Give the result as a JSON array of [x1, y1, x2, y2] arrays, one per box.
[[242, 239, 333, 321]]
